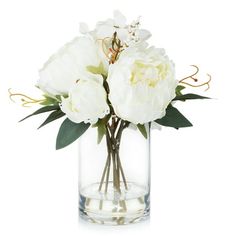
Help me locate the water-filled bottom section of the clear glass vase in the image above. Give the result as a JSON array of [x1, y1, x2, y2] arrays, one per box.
[[79, 183, 150, 225]]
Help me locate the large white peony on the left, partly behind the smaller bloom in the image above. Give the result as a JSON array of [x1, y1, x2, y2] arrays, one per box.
[[37, 37, 106, 96]]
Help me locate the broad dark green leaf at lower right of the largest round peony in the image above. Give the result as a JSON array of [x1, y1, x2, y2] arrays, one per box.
[[155, 105, 193, 129]]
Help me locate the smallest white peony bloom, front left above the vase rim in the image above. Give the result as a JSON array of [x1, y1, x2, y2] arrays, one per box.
[[61, 79, 110, 124]]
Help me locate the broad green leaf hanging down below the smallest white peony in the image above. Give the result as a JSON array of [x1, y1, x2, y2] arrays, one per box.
[[56, 118, 90, 150]]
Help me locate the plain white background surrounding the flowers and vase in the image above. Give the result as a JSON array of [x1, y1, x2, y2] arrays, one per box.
[[0, 0, 236, 236]]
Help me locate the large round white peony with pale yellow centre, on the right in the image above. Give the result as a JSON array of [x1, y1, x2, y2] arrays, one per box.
[[107, 47, 178, 124]]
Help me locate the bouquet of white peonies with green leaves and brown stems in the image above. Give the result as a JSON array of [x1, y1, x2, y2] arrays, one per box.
[[10, 11, 210, 225]]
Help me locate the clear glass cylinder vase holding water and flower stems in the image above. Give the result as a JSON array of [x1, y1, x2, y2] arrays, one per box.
[[79, 120, 150, 225]]
